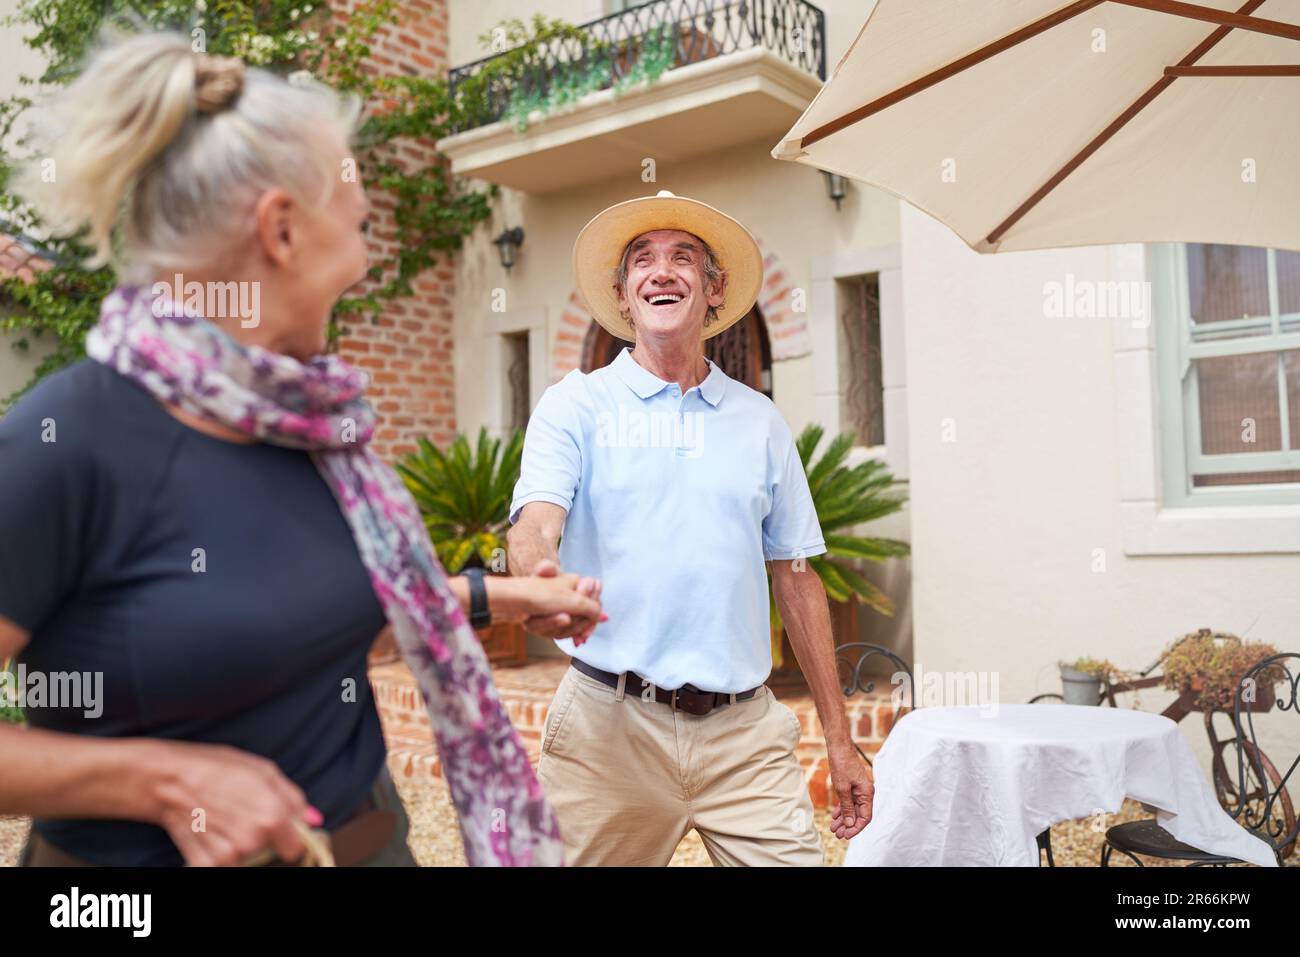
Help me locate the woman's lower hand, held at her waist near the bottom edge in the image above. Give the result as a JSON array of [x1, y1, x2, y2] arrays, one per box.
[[144, 741, 324, 866]]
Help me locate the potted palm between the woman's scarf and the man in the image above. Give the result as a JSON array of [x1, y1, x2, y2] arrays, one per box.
[[397, 429, 528, 664]]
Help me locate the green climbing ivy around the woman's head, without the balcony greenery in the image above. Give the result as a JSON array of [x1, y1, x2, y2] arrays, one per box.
[[0, 0, 497, 404]]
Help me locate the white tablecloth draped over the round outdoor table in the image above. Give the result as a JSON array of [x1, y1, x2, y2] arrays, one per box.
[[844, 705, 1277, 867]]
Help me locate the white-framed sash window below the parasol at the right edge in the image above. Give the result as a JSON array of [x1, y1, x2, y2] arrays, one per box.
[[1157, 243, 1300, 506]]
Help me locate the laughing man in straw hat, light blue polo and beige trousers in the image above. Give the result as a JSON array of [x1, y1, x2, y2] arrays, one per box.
[[508, 190, 872, 866]]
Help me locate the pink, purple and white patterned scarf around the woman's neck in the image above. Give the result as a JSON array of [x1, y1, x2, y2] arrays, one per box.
[[86, 287, 563, 866]]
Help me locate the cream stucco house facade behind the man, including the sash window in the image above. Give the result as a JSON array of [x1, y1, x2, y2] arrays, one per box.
[[442, 0, 1300, 769]]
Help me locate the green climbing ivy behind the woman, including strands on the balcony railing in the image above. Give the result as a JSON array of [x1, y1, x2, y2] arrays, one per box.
[[0, 0, 676, 408]]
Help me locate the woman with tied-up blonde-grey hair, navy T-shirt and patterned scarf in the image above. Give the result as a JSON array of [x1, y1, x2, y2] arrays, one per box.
[[0, 34, 601, 865]]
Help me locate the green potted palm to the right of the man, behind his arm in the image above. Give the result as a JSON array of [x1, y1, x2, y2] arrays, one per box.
[[768, 425, 911, 684]]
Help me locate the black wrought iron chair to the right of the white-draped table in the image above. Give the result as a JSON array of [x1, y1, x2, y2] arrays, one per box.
[[1101, 653, 1300, 867]]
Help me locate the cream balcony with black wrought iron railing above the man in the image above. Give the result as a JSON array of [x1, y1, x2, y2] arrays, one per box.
[[438, 0, 826, 192]]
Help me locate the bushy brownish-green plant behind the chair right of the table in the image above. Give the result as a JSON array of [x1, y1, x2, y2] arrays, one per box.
[[1164, 628, 1283, 714]]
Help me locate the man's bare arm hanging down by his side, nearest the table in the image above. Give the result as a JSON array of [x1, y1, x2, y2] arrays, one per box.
[[771, 560, 875, 839]]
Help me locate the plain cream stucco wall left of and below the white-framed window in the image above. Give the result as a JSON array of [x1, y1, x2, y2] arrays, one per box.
[[901, 205, 1300, 757]]
